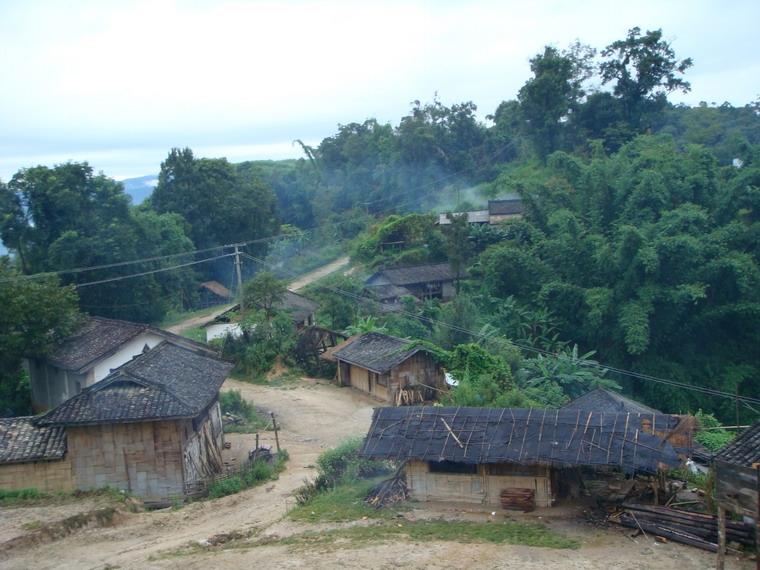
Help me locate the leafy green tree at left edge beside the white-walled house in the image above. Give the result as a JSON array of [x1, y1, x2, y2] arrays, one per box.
[[0, 257, 80, 415]]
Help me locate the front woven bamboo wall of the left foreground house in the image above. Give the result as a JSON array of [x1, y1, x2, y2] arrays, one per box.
[[66, 421, 184, 501]]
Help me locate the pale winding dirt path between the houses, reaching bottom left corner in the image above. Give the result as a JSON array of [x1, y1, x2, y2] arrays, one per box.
[[0, 379, 374, 569]]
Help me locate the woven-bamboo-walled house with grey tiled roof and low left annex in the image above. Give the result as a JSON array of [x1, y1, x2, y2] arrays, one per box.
[[0, 342, 232, 504]]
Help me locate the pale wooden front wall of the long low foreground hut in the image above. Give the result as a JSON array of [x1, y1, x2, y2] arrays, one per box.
[[406, 461, 552, 507]]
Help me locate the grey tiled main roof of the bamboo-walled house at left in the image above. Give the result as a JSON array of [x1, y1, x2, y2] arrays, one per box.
[[39, 342, 232, 425]]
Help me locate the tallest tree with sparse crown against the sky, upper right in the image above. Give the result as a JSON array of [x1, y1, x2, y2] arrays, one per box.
[[599, 27, 693, 129]]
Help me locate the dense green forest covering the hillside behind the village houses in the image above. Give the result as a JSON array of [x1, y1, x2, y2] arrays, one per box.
[[0, 28, 760, 419]]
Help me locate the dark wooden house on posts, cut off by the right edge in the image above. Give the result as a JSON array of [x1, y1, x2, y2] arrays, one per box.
[[714, 422, 760, 570]]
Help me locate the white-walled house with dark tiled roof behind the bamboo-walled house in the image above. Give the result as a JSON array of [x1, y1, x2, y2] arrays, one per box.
[[25, 317, 214, 412]]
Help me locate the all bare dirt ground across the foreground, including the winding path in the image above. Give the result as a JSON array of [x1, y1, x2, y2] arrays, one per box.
[[0, 379, 754, 570]]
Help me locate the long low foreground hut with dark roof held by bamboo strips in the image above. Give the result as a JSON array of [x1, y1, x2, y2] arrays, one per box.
[[361, 406, 681, 510]]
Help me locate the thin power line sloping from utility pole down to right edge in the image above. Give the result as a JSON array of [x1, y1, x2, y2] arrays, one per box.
[[242, 253, 760, 405]]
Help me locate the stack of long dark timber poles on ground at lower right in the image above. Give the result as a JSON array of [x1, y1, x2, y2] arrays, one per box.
[[610, 504, 755, 552]]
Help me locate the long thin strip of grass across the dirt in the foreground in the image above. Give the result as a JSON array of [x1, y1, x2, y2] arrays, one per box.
[[253, 520, 580, 549]]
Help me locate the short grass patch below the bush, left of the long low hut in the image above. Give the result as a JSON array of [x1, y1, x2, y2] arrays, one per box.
[[288, 477, 397, 522]]
